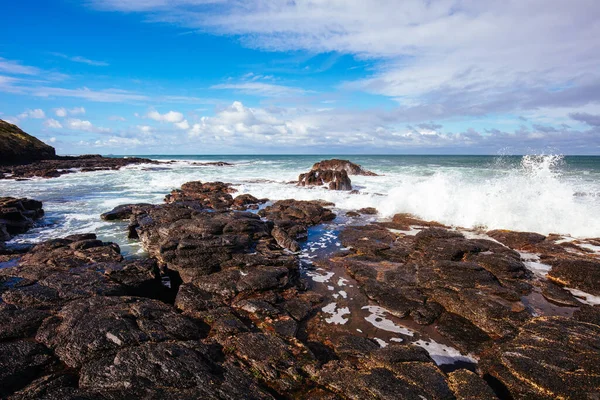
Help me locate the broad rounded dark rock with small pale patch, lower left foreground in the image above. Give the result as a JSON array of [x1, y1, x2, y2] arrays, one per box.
[[36, 297, 205, 368]]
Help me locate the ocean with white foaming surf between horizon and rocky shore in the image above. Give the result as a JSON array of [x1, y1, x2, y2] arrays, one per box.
[[0, 155, 600, 255]]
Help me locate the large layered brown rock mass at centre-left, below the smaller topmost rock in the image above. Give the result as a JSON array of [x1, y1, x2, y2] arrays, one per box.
[[134, 203, 294, 282]]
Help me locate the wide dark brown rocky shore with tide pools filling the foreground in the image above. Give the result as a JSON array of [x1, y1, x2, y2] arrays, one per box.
[[0, 173, 600, 399]]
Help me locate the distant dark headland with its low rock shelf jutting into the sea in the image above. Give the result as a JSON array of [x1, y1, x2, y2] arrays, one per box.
[[0, 120, 156, 179]]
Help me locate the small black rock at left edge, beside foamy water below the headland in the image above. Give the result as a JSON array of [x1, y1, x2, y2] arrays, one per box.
[[0, 197, 44, 242]]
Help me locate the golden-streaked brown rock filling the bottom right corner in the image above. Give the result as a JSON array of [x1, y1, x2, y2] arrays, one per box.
[[479, 317, 600, 399]]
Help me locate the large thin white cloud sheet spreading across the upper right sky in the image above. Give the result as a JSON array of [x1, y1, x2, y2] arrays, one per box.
[[89, 0, 600, 116]]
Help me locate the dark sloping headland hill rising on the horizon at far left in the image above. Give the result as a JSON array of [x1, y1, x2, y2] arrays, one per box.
[[0, 120, 56, 165]]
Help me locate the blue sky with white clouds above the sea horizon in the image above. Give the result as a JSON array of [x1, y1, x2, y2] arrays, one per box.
[[0, 0, 600, 155]]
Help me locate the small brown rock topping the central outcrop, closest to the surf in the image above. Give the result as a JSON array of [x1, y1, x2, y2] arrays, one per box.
[[165, 181, 237, 210]]
